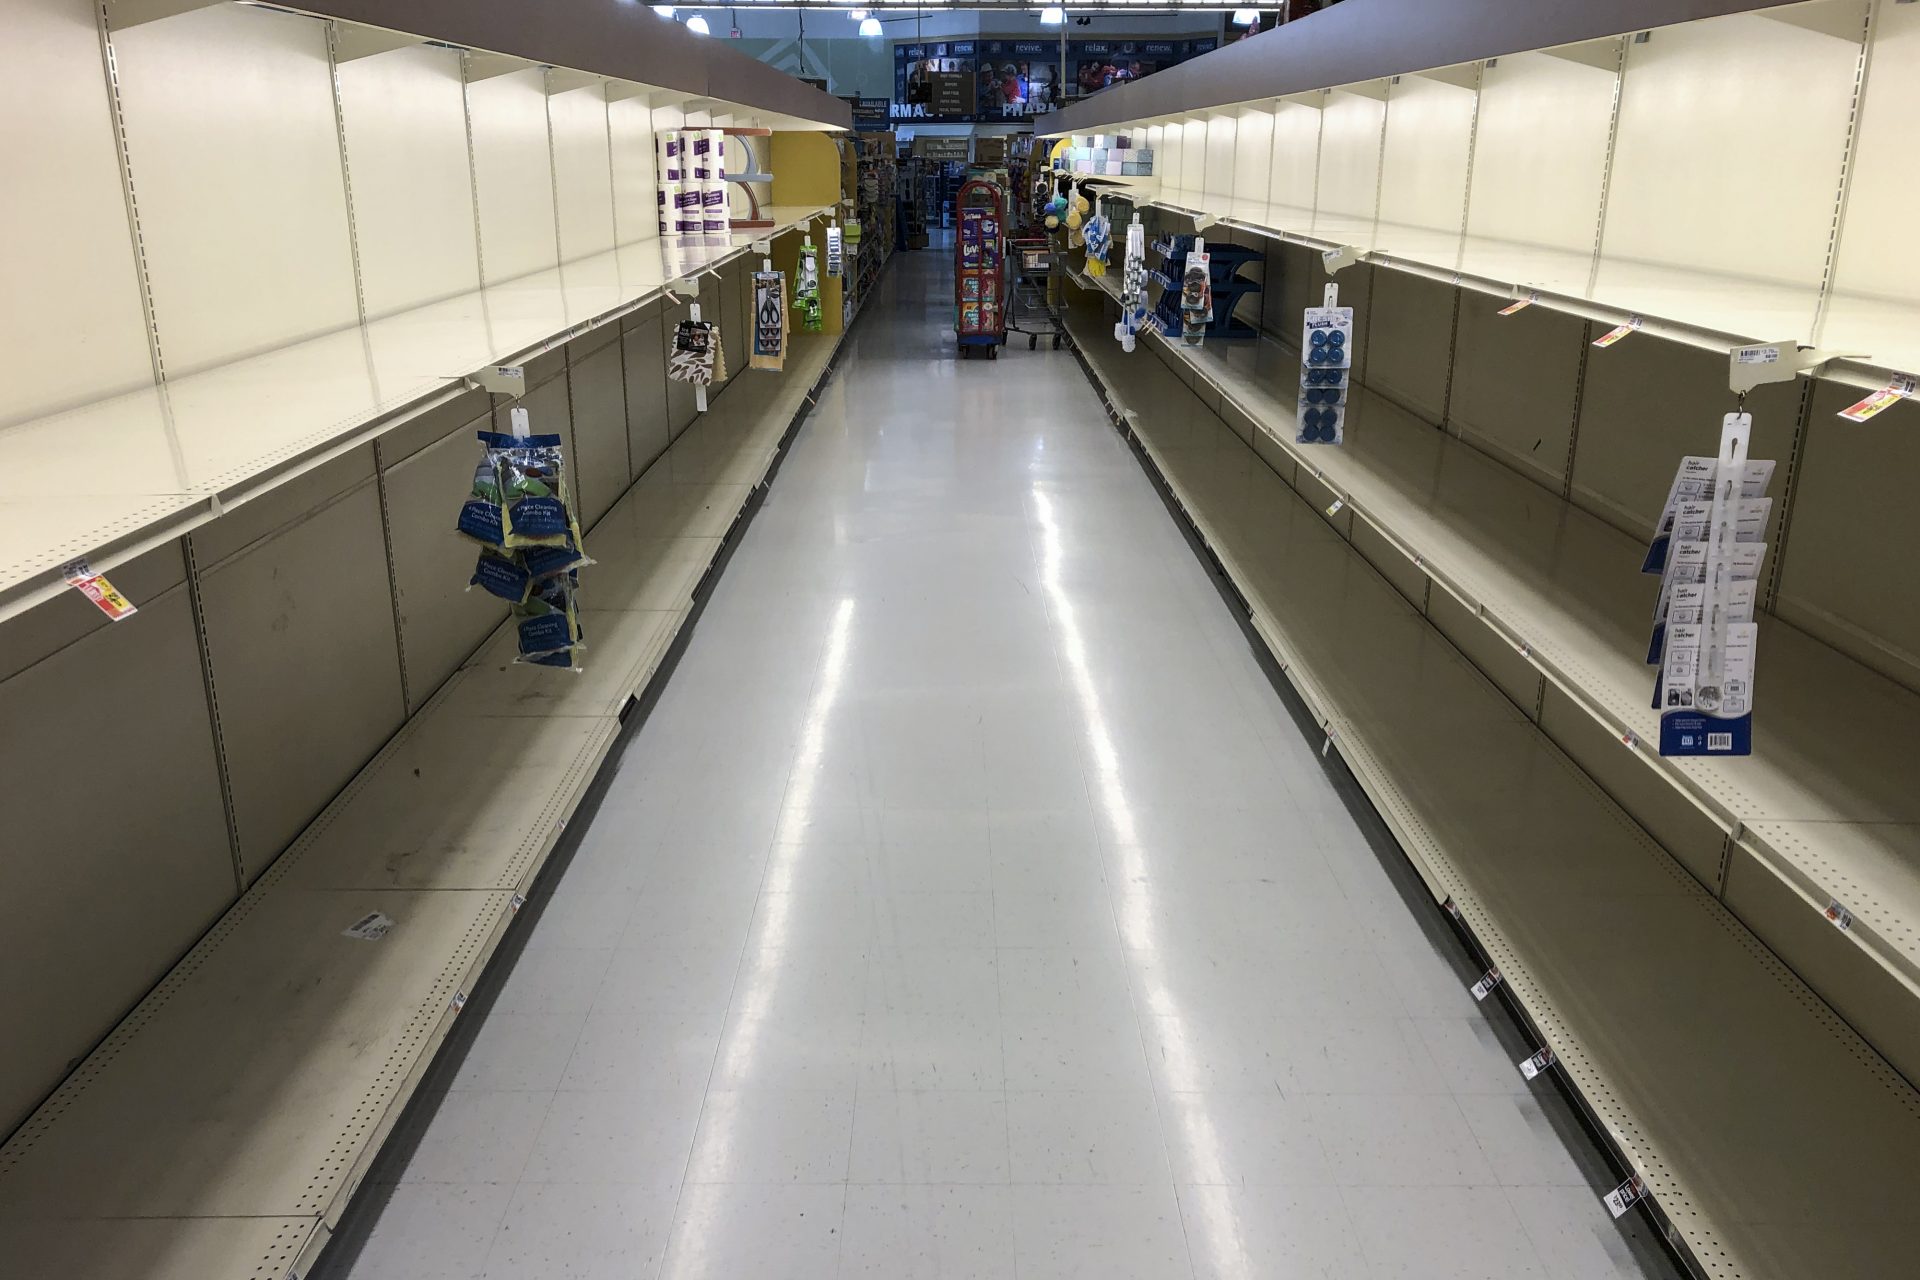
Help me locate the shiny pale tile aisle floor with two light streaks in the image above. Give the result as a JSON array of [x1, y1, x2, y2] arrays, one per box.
[[328, 253, 1672, 1280]]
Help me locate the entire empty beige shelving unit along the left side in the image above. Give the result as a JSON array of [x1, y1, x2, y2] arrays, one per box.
[[0, 0, 851, 1243]]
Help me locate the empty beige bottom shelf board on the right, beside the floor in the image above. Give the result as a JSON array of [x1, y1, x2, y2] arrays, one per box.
[[1071, 295, 1920, 1280]]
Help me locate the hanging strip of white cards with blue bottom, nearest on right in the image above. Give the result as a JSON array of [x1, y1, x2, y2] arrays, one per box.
[[1642, 413, 1774, 756]]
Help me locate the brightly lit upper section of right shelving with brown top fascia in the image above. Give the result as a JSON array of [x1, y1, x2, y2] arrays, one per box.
[[1048, 0, 1920, 390]]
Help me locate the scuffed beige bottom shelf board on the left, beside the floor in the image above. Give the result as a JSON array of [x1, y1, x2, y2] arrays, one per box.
[[0, 322, 839, 1280]]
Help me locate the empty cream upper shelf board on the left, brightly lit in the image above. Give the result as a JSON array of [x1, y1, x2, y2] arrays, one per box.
[[0, 205, 826, 618]]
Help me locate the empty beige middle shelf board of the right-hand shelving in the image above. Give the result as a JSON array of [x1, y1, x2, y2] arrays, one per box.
[[1075, 260, 1920, 1020]]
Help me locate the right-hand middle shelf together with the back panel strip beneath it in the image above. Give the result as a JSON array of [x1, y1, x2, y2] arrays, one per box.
[[1077, 249, 1920, 1077]]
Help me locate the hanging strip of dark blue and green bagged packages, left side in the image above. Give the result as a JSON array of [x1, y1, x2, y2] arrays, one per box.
[[457, 409, 591, 668]]
